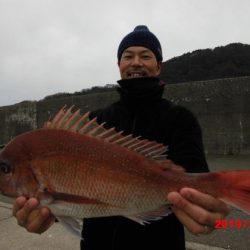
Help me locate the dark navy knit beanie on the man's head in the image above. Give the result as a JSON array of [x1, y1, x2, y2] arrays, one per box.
[[117, 25, 163, 62]]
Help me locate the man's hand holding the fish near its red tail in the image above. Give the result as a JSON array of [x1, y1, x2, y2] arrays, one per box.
[[167, 188, 229, 235]]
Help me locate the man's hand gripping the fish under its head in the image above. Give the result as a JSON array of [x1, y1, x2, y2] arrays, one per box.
[[13, 196, 55, 234]]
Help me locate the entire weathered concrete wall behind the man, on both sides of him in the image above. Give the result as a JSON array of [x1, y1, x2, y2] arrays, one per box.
[[0, 77, 250, 154]]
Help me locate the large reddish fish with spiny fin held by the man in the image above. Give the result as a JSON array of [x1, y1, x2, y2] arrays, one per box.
[[0, 106, 250, 235]]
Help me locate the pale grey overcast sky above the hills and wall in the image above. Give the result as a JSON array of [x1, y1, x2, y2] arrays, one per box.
[[0, 0, 250, 106]]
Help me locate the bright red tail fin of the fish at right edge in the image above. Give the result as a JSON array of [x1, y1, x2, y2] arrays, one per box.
[[214, 170, 250, 214]]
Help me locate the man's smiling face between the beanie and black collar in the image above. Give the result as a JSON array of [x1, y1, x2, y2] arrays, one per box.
[[118, 46, 161, 79]]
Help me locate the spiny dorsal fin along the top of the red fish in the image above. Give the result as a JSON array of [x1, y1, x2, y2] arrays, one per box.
[[43, 106, 167, 162]]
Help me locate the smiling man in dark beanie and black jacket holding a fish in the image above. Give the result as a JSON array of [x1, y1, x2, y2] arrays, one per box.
[[13, 26, 228, 250]]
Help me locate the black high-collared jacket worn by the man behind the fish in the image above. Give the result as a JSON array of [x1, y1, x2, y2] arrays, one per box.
[[81, 78, 208, 250]]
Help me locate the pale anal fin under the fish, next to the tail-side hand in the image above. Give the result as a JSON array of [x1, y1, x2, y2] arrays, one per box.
[[125, 204, 172, 225]]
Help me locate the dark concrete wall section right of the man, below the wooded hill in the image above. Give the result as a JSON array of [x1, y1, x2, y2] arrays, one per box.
[[166, 77, 250, 154]]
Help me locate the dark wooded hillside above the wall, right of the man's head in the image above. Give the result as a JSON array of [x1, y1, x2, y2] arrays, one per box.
[[161, 43, 250, 83]]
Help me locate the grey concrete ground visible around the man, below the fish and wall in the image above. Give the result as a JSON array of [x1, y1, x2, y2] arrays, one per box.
[[0, 155, 250, 250]]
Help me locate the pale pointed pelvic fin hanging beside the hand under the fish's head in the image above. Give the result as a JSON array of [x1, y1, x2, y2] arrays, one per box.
[[56, 216, 83, 239]]
